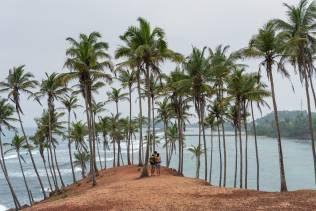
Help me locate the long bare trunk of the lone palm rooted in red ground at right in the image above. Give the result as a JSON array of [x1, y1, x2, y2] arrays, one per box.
[[267, 67, 287, 192]]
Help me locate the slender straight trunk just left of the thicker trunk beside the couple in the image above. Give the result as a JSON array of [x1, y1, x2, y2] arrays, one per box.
[[137, 74, 143, 166]]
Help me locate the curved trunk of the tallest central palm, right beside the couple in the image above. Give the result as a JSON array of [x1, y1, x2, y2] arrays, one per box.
[[141, 71, 151, 177]]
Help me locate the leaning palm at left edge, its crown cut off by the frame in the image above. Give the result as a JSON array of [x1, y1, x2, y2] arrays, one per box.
[[0, 99, 21, 209]]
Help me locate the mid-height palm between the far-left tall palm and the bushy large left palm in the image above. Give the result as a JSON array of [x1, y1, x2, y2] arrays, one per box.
[[34, 73, 68, 187]]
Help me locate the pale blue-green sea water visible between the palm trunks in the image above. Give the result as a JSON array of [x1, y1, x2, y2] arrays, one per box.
[[0, 129, 315, 211]]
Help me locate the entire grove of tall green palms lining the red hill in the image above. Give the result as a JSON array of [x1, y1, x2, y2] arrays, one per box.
[[0, 0, 316, 208]]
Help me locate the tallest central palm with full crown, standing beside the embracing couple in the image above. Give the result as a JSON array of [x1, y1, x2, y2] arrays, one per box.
[[119, 18, 182, 177]]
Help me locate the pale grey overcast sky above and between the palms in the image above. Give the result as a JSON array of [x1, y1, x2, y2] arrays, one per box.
[[0, 0, 306, 127]]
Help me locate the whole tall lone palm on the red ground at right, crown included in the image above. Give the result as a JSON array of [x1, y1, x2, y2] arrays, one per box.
[[243, 22, 289, 191]]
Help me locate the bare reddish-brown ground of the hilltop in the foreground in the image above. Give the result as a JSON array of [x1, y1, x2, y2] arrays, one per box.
[[26, 166, 316, 211]]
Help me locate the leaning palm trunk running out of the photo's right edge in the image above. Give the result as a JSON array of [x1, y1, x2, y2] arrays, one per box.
[[303, 68, 316, 183]]
